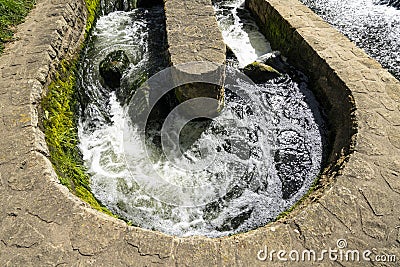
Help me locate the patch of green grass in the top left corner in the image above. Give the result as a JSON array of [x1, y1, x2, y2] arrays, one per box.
[[0, 0, 35, 53]]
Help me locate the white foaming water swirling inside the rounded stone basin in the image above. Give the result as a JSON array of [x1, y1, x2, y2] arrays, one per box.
[[79, 0, 324, 237]]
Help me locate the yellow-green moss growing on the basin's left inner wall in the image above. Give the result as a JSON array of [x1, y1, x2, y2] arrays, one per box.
[[40, 0, 113, 216]]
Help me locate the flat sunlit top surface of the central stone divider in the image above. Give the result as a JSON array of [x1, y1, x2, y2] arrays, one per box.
[[164, 0, 226, 66]]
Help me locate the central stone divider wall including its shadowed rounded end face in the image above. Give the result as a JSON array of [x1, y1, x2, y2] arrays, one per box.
[[164, 0, 226, 110]]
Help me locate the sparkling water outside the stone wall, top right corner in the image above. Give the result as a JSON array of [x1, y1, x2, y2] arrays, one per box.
[[301, 0, 400, 79]]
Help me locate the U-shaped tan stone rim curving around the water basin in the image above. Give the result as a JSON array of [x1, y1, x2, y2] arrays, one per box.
[[0, 0, 400, 266]]
